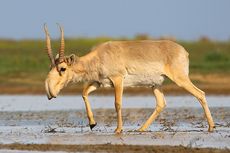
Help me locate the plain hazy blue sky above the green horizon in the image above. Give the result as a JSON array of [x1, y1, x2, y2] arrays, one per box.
[[0, 0, 230, 40]]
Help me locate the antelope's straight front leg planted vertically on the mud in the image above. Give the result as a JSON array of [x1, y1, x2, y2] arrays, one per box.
[[111, 76, 123, 134]]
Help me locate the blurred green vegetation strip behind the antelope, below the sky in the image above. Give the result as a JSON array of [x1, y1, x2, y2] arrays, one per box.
[[0, 37, 230, 87]]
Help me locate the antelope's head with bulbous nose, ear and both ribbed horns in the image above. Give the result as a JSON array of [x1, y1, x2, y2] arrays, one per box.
[[44, 24, 76, 100]]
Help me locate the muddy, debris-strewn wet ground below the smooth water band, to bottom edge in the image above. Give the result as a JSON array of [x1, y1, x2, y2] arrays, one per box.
[[0, 107, 230, 153]]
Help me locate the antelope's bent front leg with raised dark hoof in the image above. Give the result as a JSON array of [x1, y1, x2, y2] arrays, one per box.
[[82, 83, 99, 130]]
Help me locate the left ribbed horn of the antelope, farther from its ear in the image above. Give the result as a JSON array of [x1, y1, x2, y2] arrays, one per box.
[[44, 24, 55, 67]]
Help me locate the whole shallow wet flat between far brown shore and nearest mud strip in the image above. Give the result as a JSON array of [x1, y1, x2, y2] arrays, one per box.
[[0, 95, 230, 148]]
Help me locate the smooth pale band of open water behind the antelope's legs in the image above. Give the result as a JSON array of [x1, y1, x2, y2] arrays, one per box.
[[0, 95, 230, 111]]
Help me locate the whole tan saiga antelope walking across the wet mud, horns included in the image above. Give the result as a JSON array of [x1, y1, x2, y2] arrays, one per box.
[[44, 25, 214, 133]]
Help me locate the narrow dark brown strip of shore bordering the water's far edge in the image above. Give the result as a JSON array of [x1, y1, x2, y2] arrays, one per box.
[[0, 84, 230, 95]]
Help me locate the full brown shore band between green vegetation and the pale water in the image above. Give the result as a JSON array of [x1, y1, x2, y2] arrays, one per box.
[[0, 74, 230, 95]]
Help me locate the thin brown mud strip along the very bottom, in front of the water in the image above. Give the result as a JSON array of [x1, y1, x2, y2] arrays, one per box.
[[0, 144, 230, 153]]
